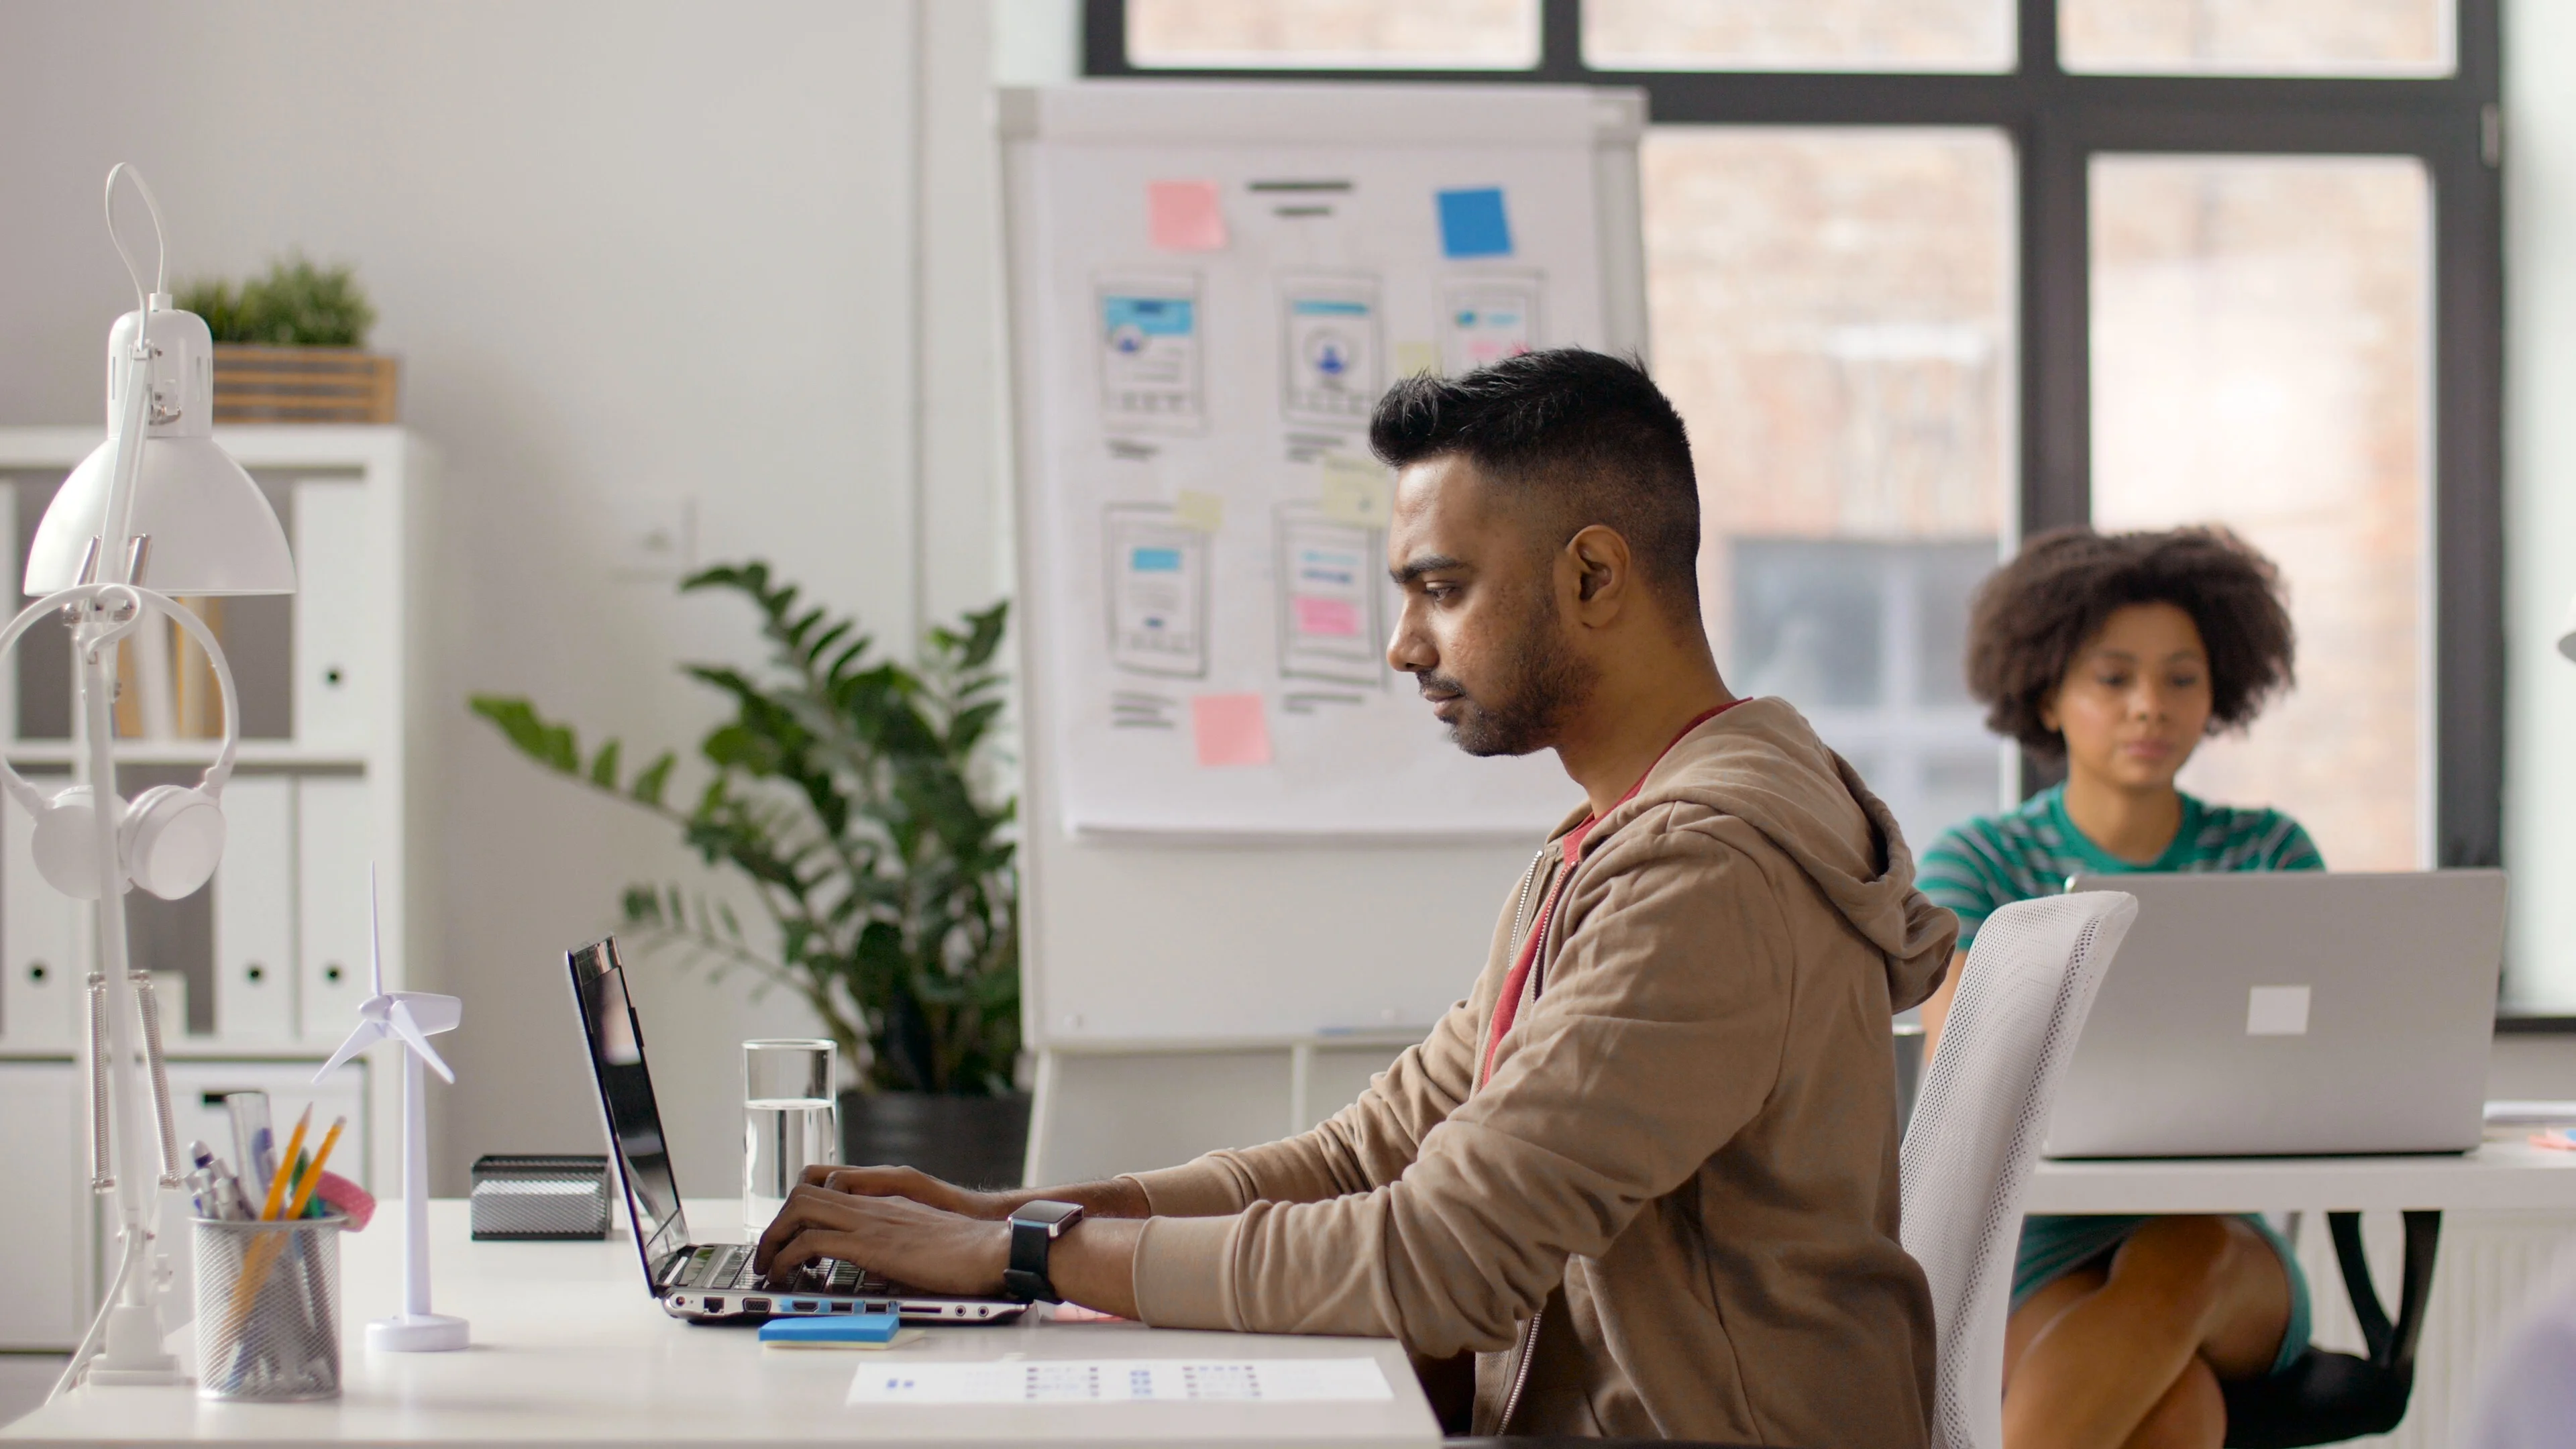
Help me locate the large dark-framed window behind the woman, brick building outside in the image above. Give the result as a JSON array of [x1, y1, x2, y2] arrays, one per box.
[[1085, 0, 2502, 969]]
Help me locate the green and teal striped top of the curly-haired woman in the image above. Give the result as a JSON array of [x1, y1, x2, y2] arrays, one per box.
[[1914, 784, 2326, 949]]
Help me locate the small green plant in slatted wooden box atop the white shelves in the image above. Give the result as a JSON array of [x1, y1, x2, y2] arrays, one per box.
[[178, 255, 399, 423]]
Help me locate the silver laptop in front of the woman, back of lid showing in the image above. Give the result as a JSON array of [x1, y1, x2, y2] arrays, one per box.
[[2043, 871, 2504, 1158]]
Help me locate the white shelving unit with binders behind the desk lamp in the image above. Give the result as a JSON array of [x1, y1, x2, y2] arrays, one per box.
[[0, 428, 435, 1348]]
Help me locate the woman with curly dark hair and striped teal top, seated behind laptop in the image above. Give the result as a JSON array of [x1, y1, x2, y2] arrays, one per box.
[[1922, 529, 2324, 1449]]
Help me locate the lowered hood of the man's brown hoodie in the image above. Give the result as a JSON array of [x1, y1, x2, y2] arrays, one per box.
[[1569, 699, 1957, 1011]]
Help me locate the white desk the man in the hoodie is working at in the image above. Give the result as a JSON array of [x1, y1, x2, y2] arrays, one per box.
[[0, 1201, 1440, 1449]]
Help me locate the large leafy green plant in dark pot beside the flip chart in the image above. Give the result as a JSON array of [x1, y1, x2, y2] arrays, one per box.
[[472, 562, 1028, 1186]]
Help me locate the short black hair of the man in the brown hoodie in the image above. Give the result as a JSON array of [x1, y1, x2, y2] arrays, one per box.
[[1368, 348, 1700, 608]]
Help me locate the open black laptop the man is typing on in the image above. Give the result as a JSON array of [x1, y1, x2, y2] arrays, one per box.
[[567, 938, 1028, 1323]]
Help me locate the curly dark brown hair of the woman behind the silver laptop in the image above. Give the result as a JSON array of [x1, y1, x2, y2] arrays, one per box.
[[1968, 526, 2298, 758]]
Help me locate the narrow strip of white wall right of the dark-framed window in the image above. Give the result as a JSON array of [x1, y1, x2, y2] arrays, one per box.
[[2504, 0, 2576, 1016]]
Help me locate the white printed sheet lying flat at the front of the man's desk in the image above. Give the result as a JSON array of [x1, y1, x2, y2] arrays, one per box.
[[847, 1358, 1393, 1405]]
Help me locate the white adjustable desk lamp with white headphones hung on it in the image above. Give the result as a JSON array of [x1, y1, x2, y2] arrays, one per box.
[[28, 165, 297, 1395]]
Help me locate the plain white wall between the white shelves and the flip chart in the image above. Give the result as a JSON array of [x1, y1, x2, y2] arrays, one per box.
[[0, 0, 1025, 1194]]
